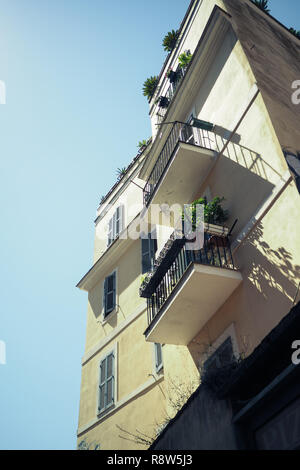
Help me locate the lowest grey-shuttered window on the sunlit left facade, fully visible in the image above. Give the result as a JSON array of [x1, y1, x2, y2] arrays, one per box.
[[98, 352, 115, 413]]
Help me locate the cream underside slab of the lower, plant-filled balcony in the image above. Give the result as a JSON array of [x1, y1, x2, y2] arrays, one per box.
[[145, 263, 242, 345]]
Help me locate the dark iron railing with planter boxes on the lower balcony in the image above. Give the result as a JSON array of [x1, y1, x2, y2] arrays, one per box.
[[144, 232, 235, 325]]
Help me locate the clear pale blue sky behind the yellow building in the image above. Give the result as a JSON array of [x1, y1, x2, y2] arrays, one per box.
[[0, 0, 300, 449]]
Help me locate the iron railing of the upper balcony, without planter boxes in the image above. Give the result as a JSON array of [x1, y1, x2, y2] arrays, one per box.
[[144, 122, 218, 205]]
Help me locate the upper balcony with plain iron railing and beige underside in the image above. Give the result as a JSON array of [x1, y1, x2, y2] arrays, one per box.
[[144, 122, 218, 206]]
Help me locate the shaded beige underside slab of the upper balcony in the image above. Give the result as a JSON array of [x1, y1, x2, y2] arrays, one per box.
[[148, 142, 217, 210]]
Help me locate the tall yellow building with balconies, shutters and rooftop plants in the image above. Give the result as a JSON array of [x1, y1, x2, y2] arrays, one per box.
[[78, 0, 300, 450]]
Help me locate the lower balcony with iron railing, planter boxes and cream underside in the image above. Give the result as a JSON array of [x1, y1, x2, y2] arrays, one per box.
[[140, 226, 242, 345]]
